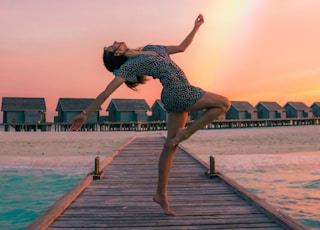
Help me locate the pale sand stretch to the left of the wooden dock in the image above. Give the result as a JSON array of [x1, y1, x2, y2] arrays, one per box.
[[0, 132, 136, 169]]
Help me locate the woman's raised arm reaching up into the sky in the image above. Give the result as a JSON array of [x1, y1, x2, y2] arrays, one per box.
[[167, 14, 204, 54]]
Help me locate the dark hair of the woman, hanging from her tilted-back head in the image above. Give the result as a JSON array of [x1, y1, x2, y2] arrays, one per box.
[[103, 50, 147, 90]]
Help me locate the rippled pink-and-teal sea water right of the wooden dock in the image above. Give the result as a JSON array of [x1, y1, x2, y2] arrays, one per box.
[[227, 169, 320, 229]]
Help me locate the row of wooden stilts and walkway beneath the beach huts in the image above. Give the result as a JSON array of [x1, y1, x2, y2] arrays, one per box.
[[0, 117, 320, 132]]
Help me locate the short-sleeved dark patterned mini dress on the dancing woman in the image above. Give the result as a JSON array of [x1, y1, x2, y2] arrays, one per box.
[[115, 45, 205, 112]]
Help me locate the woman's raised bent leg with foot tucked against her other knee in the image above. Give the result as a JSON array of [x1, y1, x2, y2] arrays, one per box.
[[169, 92, 230, 146]]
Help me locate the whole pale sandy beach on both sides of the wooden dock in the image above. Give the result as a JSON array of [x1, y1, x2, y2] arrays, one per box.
[[0, 126, 320, 171]]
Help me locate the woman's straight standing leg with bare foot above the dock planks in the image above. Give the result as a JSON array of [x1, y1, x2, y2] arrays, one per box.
[[153, 112, 188, 216]]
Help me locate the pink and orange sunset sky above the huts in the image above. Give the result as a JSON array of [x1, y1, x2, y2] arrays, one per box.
[[0, 0, 320, 120]]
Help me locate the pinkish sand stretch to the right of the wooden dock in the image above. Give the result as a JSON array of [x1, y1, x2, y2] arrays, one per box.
[[181, 126, 320, 172]]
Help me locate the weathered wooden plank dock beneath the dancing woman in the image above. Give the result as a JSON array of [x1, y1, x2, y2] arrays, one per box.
[[27, 134, 307, 230]]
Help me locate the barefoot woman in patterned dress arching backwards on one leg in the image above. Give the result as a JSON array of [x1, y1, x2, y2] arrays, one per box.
[[71, 14, 230, 216]]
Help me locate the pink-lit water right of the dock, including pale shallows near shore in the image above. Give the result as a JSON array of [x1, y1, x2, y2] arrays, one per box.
[[205, 152, 320, 229]]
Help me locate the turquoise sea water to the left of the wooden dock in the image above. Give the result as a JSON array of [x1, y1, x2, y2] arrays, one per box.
[[0, 167, 85, 230]]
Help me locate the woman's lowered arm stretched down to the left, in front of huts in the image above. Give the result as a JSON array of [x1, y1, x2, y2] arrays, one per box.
[[70, 77, 125, 130]]
